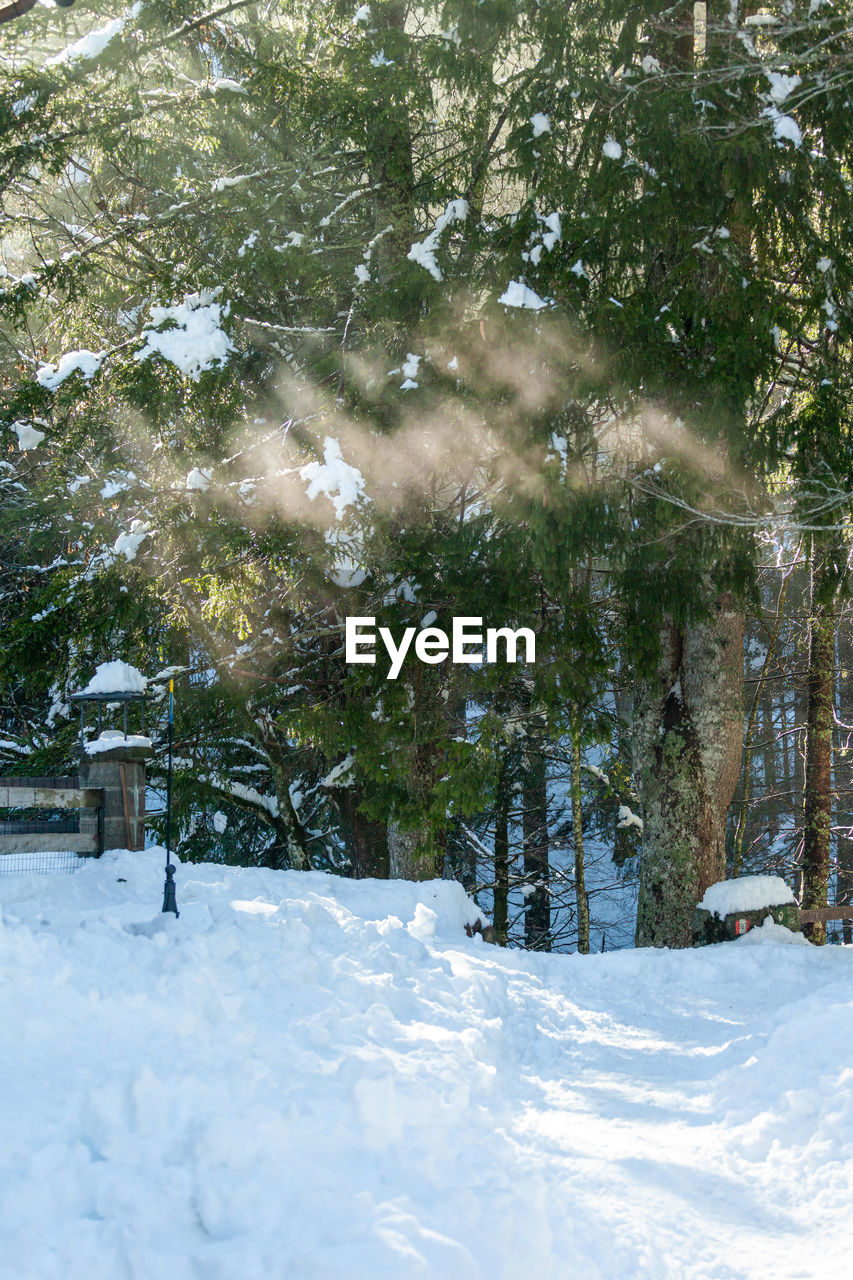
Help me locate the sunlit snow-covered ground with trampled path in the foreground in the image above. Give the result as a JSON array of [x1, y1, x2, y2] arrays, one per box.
[[0, 850, 853, 1280]]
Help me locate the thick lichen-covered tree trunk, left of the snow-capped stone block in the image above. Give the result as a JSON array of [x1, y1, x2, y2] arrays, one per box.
[[634, 596, 744, 947]]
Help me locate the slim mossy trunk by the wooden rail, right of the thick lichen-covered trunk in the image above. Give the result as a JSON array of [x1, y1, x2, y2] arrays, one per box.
[[802, 534, 836, 942]]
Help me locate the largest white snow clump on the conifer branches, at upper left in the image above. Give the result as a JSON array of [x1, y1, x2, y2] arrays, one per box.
[[134, 289, 234, 381]]
